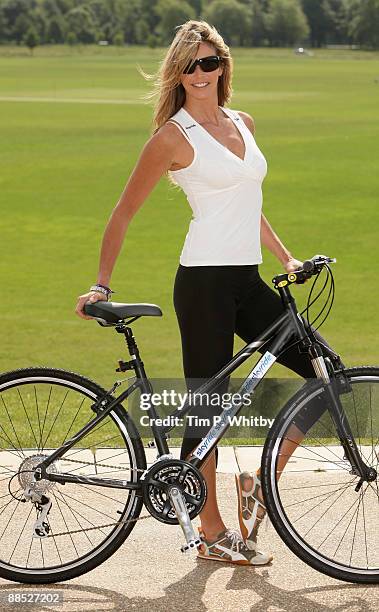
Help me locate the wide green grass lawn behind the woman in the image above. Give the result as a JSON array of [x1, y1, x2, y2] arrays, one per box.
[[0, 47, 379, 392]]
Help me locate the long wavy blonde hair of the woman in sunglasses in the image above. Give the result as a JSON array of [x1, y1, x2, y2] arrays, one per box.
[[138, 19, 233, 134]]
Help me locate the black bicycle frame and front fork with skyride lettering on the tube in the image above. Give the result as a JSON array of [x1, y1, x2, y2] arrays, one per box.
[[35, 286, 376, 489]]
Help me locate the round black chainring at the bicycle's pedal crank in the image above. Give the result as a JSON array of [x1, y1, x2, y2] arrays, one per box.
[[140, 459, 207, 525]]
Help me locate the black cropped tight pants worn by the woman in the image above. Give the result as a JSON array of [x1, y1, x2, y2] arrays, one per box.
[[173, 264, 336, 459]]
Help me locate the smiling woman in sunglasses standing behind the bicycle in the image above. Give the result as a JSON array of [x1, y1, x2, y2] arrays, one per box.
[[76, 20, 332, 565]]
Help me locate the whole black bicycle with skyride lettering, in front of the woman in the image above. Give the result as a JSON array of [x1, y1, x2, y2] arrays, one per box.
[[0, 255, 379, 583]]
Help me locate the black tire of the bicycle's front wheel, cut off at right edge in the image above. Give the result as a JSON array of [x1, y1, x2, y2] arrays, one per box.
[[261, 366, 379, 584]]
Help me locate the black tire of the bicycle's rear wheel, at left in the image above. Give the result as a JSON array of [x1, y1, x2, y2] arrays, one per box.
[[0, 367, 146, 584]]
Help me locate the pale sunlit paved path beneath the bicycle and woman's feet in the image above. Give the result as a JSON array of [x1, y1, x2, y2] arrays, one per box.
[[0, 447, 379, 612]]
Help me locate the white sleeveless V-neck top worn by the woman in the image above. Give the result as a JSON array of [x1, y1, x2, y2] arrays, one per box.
[[169, 106, 267, 266]]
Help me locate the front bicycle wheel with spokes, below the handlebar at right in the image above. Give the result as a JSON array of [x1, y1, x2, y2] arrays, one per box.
[[262, 367, 379, 583]]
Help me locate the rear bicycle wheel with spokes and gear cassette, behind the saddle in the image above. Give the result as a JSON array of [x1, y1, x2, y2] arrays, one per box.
[[0, 368, 146, 583]]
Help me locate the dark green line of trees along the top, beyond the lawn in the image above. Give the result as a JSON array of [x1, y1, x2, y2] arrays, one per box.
[[0, 0, 379, 49]]
